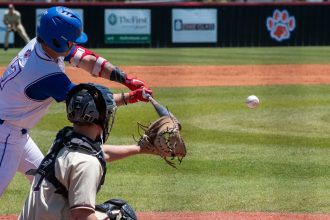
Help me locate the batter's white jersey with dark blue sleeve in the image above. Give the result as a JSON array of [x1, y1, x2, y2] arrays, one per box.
[[0, 39, 73, 129]]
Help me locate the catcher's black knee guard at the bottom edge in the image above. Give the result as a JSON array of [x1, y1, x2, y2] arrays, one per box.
[[95, 199, 137, 220]]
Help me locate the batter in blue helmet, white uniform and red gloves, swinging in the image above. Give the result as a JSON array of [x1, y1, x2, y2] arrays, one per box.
[[0, 6, 152, 196]]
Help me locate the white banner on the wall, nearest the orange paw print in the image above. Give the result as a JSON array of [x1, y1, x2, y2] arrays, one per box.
[[172, 9, 217, 43]]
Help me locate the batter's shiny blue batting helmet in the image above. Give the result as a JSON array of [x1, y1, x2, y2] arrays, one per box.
[[37, 6, 88, 53]]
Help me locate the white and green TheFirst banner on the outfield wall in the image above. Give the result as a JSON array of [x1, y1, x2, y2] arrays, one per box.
[[104, 9, 151, 44]]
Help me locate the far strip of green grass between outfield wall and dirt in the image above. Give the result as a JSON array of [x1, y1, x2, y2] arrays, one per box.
[[0, 47, 330, 66]]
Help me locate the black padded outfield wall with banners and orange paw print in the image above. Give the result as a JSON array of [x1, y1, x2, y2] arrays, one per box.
[[0, 2, 330, 48]]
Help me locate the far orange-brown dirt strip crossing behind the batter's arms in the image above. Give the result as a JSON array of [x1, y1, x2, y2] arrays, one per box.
[[67, 65, 330, 88]]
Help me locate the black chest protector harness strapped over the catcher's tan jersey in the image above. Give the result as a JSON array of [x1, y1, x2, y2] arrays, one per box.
[[26, 127, 106, 198]]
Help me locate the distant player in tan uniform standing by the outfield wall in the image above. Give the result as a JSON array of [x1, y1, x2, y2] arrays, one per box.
[[3, 4, 30, 50]]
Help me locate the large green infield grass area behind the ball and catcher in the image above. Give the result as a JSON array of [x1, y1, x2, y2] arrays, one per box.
[[0, 86, 330, 214]]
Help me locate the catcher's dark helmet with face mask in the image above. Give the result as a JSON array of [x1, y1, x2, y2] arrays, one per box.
[[66, 83, 116, 142]]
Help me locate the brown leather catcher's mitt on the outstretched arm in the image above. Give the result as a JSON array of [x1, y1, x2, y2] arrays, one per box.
[[138, 115, 187, 168]]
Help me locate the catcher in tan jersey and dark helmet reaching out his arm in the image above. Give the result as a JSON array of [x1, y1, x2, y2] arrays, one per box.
[[19, 84, 186, 220]]
